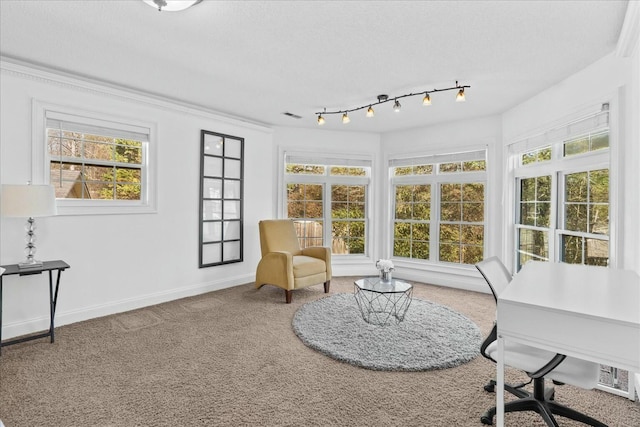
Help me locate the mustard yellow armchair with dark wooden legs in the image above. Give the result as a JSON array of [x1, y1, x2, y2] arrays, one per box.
[[256, 219, 331, 304]]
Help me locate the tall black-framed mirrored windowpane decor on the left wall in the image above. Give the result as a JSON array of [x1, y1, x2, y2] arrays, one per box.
[[198, 130, 244, 268]]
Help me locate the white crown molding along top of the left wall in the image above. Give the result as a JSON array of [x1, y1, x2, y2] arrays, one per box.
[[0, 56, 273, 133]]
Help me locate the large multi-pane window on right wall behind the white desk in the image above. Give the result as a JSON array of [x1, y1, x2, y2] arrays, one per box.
[[510, 110, 609, 270]]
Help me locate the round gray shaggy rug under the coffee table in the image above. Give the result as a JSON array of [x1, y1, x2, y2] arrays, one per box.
[[292, 294, 482, 371]]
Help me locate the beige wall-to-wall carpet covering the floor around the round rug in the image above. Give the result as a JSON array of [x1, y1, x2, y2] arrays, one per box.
[[0, 277, 640, 427]]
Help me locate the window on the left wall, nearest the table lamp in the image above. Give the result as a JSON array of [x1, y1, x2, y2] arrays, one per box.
[[34, 103, 155, 214]]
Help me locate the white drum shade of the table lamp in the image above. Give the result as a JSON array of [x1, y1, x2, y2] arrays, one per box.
[[1, 184, 56, 218]]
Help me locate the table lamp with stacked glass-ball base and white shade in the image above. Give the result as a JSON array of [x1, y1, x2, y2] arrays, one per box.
[[0, 184, 56, 268]]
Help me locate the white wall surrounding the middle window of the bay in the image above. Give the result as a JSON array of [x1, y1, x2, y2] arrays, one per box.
[[378, 116, 503, 292]]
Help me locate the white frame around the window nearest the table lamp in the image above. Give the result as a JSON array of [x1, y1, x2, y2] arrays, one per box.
[[31, 99, 157, 215]]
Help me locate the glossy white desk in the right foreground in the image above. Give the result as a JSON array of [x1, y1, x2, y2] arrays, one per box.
[[496, 262, 640, 427]]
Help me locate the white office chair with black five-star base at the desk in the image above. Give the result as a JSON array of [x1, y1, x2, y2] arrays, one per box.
[[476, 257, 607, 427]]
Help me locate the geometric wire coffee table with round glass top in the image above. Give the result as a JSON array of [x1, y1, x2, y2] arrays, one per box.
[[353, 277, 413, 326]]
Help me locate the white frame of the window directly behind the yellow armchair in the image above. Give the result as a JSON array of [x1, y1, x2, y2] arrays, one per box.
[[279, 150, 373, 260]]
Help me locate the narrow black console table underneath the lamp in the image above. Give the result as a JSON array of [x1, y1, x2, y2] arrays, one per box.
[[0, 260, 70, 355]]
